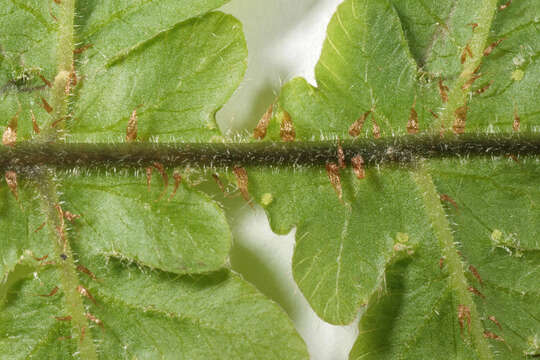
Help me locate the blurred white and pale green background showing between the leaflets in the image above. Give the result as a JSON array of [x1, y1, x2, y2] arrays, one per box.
[[217, 0, 358, 360]]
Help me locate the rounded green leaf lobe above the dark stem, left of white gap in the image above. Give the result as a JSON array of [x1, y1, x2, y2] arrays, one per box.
[[69, 13, 247, 142]]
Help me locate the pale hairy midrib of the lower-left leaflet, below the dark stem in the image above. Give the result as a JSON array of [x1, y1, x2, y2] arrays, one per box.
[[36, 173, 97, 360]]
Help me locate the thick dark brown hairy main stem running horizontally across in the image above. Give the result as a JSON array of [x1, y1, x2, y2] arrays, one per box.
[[0, 133, 540, 170]]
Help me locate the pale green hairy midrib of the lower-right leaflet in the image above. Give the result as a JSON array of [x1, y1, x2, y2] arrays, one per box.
[[412, 167, 493, 360]]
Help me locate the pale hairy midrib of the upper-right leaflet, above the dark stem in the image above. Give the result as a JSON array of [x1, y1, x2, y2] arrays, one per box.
[[441, 0, 497, 129]]
